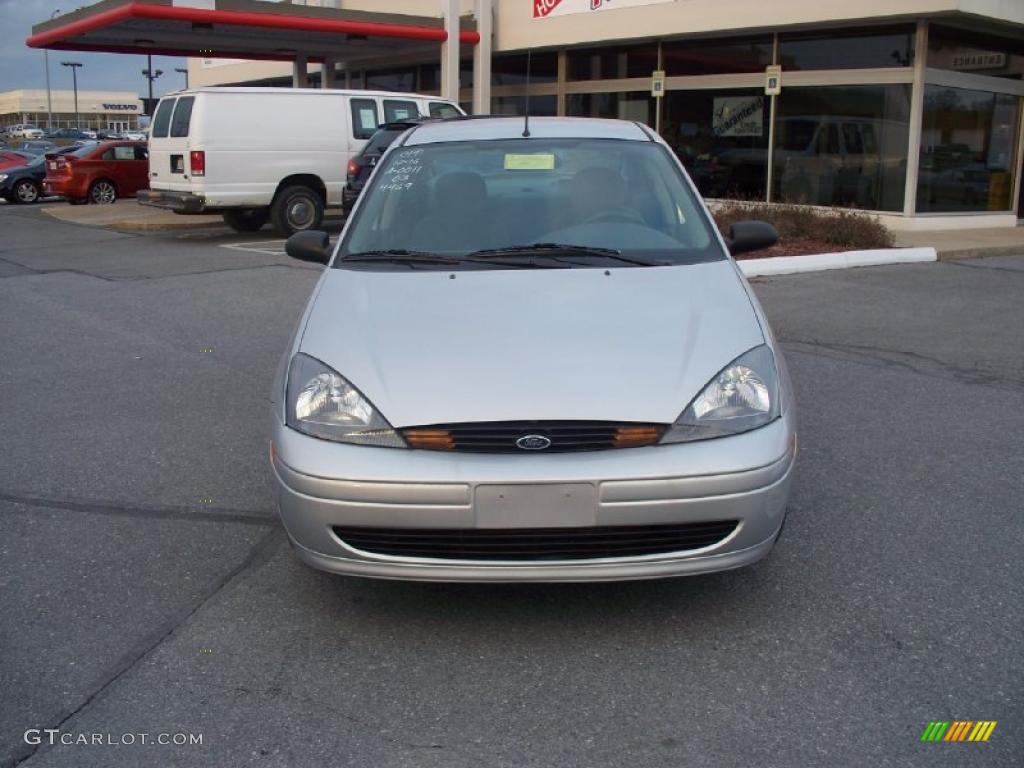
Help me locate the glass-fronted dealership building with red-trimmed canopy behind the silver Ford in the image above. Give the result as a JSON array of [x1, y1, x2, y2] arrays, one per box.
[[29, 0, 1024, 228]]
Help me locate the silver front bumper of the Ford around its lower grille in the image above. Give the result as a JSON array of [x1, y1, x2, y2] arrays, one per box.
[[271, 415, 796, 582]]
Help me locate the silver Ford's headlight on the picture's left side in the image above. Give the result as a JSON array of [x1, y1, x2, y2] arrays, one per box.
[[286, 353, 406, 447]]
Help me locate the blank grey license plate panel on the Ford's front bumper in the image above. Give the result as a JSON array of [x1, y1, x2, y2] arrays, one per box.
[[473, 482, 597, 528]]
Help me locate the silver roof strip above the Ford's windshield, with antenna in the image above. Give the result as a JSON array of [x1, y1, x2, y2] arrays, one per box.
[[406, 117, 652, 146]]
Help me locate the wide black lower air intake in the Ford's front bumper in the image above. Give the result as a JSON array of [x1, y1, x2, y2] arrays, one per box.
[[334, 520, 738, 562]]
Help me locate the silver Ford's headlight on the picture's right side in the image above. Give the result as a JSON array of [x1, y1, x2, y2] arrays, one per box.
[[662, 345, 779, 442]]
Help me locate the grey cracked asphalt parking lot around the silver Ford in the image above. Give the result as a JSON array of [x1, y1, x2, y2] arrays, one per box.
[[0, 201, 1024, 768]]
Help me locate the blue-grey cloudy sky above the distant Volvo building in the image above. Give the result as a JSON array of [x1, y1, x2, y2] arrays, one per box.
[[0, 0, 185, 96]]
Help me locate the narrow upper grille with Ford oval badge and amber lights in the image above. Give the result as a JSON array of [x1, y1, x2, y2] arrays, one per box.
[[401, 421, 665, 454]]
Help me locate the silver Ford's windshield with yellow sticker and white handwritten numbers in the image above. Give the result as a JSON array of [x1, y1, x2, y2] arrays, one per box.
[[334, 138, 725, 268]]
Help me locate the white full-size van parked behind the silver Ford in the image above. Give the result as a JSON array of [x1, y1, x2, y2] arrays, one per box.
[[138, 87, 465, 234]]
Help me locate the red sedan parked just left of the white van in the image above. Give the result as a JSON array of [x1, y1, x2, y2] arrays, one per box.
[[43, 141, 150, 203]]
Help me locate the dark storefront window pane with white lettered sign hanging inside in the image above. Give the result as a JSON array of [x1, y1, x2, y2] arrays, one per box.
[[662, 89, 771, 200]]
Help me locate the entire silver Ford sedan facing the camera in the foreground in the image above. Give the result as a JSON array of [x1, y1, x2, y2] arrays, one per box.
[[270, 118, 797, 581]]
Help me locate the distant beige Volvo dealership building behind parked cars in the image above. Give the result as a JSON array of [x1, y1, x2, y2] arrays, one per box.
[[0, 90, 142, 131]]
